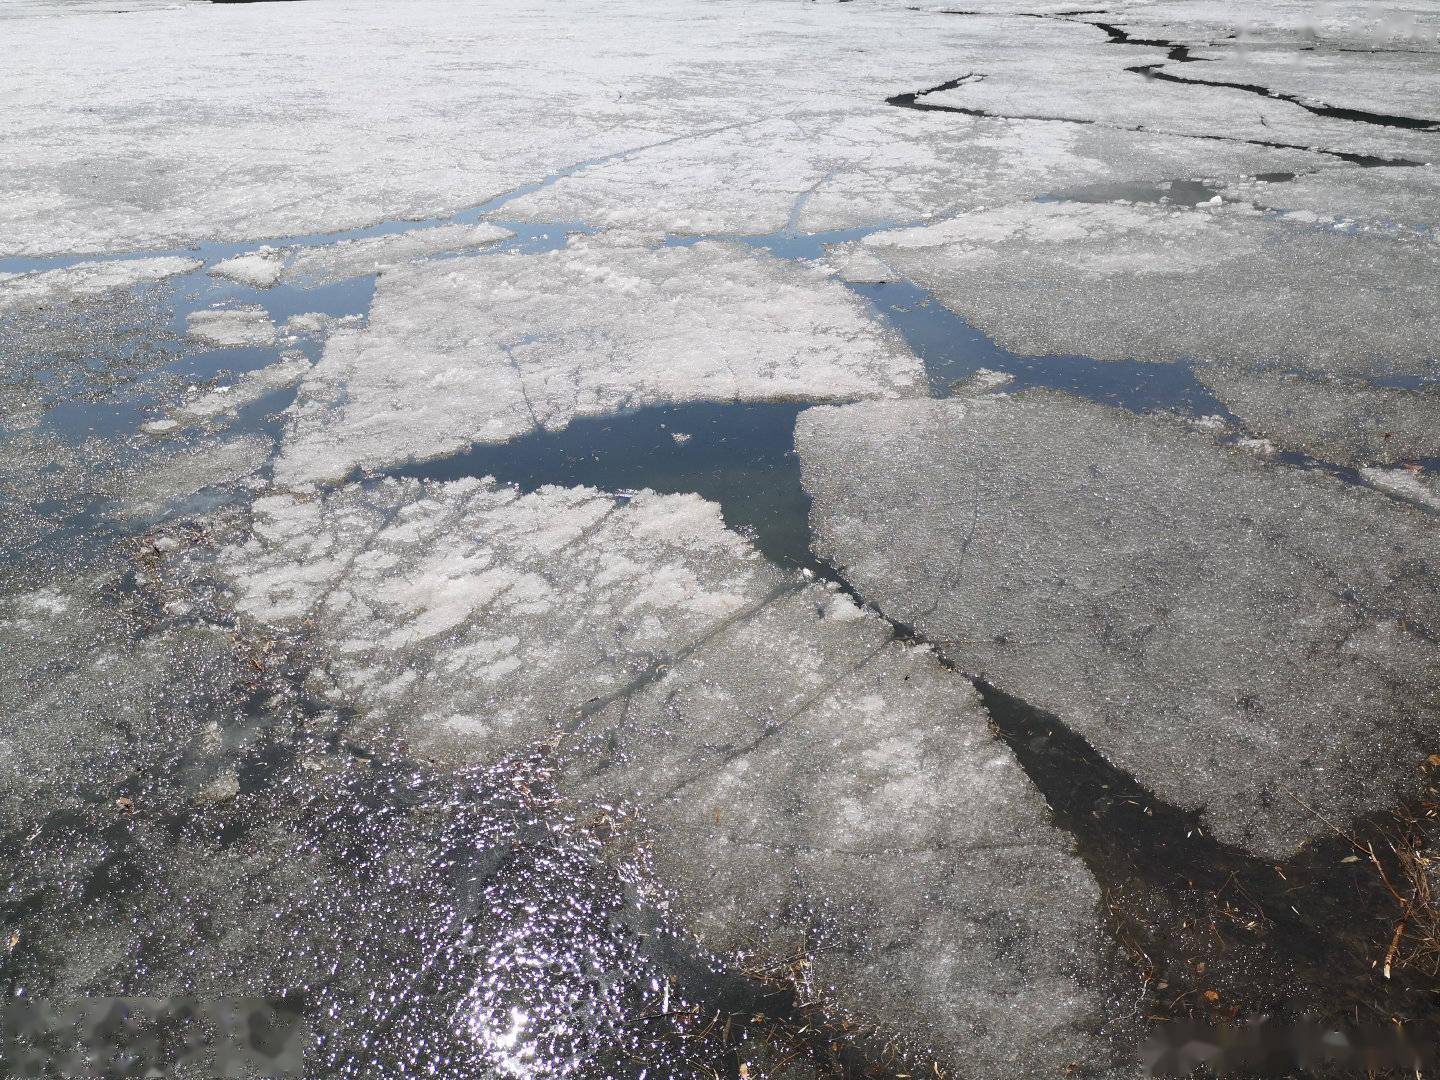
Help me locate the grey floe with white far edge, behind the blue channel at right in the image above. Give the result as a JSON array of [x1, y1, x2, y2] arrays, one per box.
[[864, 202, 1440, 376]]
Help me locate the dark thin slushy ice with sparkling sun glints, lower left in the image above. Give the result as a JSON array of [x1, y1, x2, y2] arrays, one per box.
[[0, 584, 696, 1080]]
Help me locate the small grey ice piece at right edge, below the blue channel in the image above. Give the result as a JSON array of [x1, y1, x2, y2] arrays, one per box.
[[1197, 366, 1440, 465]]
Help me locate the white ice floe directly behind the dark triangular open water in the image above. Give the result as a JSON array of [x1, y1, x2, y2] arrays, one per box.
[[275, 242, 926, 484]]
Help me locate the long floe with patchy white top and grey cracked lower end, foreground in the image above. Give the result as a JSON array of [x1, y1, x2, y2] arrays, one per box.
[[177, 480, 1102, 1077]]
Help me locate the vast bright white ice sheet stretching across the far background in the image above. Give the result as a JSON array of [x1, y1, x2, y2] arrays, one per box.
[[0, 0, 1365, 255]]
